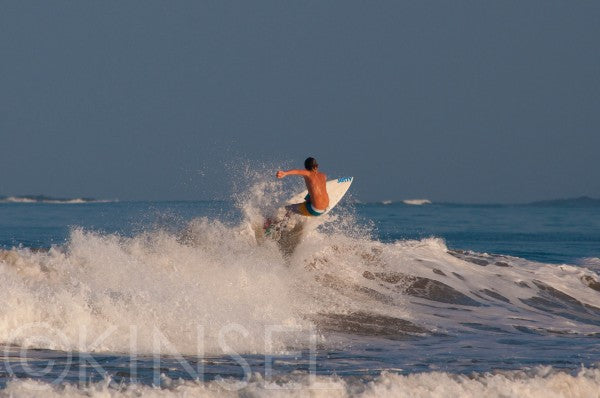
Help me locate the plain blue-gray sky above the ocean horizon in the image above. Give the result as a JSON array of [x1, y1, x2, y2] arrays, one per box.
[[0, 0, 600, 202]]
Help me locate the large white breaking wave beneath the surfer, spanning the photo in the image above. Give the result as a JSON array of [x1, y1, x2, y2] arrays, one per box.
[[0, 180, 600, 355]]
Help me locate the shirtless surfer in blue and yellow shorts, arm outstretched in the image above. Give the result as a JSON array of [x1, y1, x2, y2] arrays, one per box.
[[277, 158, 329, 216]]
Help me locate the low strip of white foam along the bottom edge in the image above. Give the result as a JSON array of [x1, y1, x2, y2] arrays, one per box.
[[3, 367, 600, 398]]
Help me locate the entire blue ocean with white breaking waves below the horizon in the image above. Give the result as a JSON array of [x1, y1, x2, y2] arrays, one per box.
[[0, 189, 600, 397]]
